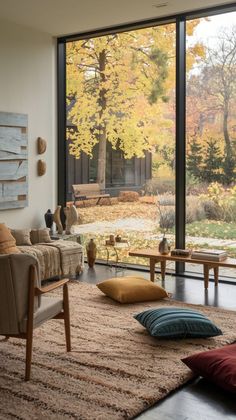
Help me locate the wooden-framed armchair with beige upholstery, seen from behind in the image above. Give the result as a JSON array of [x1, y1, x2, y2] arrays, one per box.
[[0, 254, 71, 381]]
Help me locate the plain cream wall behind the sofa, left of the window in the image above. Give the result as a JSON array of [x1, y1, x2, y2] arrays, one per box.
[[0, 21, 56, 228]]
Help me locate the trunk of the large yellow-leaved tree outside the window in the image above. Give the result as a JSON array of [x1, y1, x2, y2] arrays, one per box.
[[97, 50, 107, 189]]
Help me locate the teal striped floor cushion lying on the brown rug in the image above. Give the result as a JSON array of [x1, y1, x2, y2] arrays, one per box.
[[134, 307, 222, 338]]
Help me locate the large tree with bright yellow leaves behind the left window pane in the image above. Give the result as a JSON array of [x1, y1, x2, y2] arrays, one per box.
[[67, 22, 204, 188]]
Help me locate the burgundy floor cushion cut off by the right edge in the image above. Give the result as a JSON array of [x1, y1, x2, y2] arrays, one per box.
[[182, 344, 236, 393]]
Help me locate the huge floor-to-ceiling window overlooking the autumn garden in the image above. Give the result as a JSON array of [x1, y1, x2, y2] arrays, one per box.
[[58, 4, 236, 275]]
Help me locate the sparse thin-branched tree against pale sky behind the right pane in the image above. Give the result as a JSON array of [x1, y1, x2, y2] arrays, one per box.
[[197, 26, 236, 183]]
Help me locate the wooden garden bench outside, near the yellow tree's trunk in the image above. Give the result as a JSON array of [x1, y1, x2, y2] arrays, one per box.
[[72, 184, 111, 204]]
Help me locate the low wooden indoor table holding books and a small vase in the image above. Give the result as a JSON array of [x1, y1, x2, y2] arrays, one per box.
[[129, 249, 236, 289]]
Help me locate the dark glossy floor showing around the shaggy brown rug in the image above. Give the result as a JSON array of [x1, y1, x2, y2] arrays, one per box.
[[78, 265, 236, 420]]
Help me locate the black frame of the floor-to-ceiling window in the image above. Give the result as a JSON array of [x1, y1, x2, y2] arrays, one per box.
[[57, 3, 236, 274]]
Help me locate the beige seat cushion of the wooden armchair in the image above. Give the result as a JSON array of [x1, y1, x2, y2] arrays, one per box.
[[20, 296, 63, 332]]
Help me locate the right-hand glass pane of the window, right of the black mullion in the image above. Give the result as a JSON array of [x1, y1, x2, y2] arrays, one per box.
[[186, 12, 236, 274]]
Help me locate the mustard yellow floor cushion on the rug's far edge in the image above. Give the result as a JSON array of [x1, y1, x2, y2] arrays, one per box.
[[97, 276, 168, 303]]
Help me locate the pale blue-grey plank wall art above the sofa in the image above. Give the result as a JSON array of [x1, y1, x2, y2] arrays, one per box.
[[0, 112, 28, 210]]
